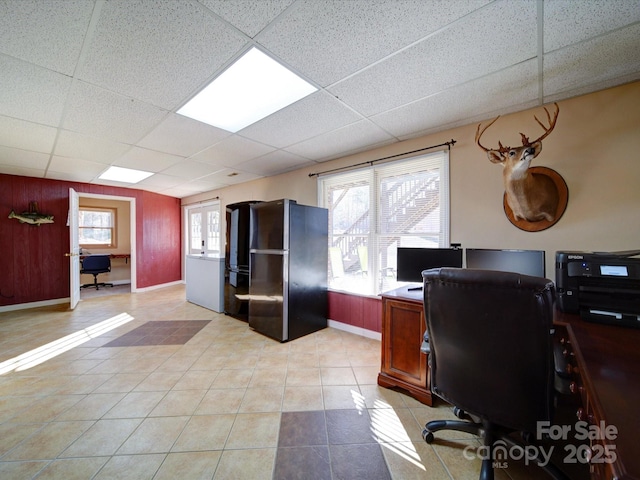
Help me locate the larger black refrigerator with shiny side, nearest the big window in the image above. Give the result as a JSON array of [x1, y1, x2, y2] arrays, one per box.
[[249, 199, 328, 342]]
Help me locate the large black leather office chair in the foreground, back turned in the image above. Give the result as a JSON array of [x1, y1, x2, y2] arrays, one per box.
[[422, 268, 568, 480]]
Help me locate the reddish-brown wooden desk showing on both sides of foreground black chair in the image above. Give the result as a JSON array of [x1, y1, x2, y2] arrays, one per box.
[[378, 287, 640, 480]]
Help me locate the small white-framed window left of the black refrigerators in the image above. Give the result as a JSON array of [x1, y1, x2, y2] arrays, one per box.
[[187, 202, 220, 255]]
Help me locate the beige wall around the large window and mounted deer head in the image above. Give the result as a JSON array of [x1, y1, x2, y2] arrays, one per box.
[[183, 82, 640, 279]]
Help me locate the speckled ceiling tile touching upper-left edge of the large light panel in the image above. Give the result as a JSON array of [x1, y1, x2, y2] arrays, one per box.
[[79, 0, 247, 110]]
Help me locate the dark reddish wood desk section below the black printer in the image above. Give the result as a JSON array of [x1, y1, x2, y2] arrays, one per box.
[[555, 312, 640, 480]]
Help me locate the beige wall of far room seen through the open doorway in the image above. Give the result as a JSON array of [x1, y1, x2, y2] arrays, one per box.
[[80, 197, 131, 284]]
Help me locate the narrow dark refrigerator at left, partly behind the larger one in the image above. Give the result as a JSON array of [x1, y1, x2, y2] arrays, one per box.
[[224, 200, 257, 322]]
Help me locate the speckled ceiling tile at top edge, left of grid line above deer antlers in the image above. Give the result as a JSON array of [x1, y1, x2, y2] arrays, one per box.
[[329, 2, 536, 116]]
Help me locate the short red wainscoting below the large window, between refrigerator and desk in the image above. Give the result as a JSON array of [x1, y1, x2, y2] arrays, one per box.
[[329, 291, 382, 333]]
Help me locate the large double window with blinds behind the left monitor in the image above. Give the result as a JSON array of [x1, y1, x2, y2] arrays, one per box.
[[318, 151, 449, 295]]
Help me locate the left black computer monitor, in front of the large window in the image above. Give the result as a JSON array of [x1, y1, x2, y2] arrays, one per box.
[[397, 247, 462, 283]]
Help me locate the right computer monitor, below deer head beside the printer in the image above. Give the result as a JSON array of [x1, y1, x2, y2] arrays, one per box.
[[466, 248, 545, 277]]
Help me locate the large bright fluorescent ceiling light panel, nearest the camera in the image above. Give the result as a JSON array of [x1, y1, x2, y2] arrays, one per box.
[[178, 47, 317, 133]]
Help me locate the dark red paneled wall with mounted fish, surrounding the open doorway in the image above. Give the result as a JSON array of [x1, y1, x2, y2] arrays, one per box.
[[0, 174, 182, 306]]
